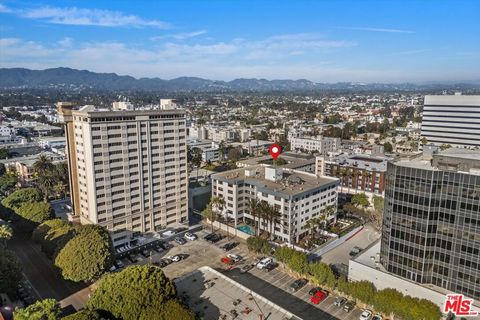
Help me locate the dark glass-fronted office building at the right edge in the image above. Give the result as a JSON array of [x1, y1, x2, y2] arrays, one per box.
[[381, 149, 480, 300]]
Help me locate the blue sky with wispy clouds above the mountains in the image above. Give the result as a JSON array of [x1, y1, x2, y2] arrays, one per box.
[[0, 0, 480, 82]]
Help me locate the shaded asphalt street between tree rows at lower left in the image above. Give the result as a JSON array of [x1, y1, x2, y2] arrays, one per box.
[[8, 230, 86, 301]]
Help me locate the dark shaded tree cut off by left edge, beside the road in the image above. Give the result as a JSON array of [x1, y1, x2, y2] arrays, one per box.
[[0, 249, 22, 299]]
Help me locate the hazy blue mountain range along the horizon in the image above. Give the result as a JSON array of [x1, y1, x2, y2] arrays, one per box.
[[0, 67, 480, 92]]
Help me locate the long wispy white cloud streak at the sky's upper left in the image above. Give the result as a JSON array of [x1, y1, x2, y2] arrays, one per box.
[[18, 6, 171, 29]]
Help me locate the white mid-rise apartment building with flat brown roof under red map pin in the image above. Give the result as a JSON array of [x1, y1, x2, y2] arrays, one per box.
[[212, 166, 338, 243]]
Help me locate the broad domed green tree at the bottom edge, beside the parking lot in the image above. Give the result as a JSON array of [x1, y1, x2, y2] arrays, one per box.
[[87, 265, 194, 320]]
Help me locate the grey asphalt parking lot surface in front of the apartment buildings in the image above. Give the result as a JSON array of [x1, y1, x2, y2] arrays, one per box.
[[113, 228, 368, 320]]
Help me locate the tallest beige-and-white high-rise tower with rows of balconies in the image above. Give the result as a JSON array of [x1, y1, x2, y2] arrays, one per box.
[[58, 102, 188, 247]]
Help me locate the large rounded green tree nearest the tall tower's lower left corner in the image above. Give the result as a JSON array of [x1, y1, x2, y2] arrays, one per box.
[[55, 225, 114, 281]]
